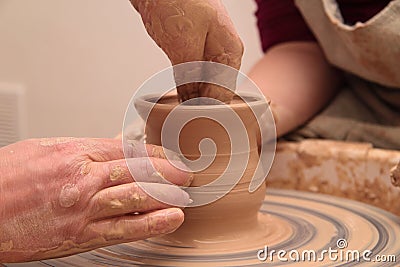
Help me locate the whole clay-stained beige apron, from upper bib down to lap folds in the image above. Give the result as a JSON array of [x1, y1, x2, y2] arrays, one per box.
[[285, 0, 400, 149]]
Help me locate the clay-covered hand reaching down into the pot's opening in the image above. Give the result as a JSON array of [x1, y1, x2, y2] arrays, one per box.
[[130, 0, 243, 102]]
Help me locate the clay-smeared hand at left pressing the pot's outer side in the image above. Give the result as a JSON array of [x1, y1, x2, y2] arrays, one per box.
[[0, 138, 190, 262]]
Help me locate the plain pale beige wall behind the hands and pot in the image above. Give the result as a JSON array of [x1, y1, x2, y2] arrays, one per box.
[[0, 0, 261, 140]]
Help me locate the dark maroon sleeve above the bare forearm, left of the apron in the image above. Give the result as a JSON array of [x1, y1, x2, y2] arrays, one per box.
[[256, 0, 316, 52]]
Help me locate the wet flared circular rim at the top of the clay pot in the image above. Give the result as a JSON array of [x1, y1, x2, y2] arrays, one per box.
[[135, 93, 268, 111]]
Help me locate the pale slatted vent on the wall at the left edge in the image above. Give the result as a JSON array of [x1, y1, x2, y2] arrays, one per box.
[[0, 83, 25, 147]]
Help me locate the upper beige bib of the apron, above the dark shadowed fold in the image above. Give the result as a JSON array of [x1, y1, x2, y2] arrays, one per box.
[[296, 0, 400, 88]]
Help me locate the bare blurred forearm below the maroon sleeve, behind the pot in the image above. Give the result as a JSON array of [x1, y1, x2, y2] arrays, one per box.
[[249, 42, 340, 136]]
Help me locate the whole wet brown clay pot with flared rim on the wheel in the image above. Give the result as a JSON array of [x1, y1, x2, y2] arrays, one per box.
[[135, 95, 282, 253]]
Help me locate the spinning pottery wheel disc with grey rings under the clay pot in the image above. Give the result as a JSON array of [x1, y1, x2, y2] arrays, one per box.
[[10, 189, 400, 267]]
